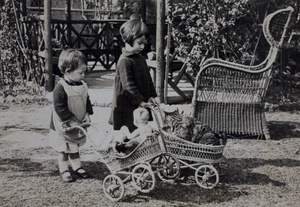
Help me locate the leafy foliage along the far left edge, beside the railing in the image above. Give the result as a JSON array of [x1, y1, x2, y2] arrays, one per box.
[[0, 0, 20, 95]]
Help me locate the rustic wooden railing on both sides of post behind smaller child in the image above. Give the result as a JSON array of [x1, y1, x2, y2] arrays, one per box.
[[21, 18, 125, 90]]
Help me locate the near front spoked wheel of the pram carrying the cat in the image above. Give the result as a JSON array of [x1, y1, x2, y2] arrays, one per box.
[[195, 165, 219, 189]]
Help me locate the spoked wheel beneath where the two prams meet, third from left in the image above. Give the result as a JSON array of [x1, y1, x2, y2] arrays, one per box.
[[151, 153, 180, 180]]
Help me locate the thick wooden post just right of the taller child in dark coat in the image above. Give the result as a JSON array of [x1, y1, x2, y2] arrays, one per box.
[[156, 0, 165, 103]]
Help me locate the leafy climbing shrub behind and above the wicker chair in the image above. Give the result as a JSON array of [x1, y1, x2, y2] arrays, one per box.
[[167, 0, 259, 69]]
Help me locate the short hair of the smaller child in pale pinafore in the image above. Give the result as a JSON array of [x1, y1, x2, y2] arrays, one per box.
[[58, 49, 87, 74]]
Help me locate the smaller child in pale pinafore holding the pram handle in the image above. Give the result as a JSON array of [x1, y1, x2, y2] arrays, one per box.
[[49, 49, 93, 182]]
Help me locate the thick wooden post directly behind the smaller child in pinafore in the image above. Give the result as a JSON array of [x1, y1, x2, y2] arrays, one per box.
[[44, 0, 54, 92]]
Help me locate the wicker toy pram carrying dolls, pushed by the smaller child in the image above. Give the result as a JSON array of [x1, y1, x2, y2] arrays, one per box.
[[65, 106, 180, 201]]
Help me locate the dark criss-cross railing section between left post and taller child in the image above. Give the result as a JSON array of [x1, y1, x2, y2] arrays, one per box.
[[41, 20, 124, 70]]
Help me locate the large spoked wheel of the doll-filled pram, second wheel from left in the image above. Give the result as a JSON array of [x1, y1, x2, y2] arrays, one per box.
[[132, 164, 156, 193]]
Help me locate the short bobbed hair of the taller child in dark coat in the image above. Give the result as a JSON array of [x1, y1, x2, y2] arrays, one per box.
[[120, 19, 148, 46]]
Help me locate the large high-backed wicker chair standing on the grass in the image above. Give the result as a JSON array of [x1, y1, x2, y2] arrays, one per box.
[[192, 7, 293, 139]]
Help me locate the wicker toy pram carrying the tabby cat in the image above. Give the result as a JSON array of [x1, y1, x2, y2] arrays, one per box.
[[151, 103, 228, 189]]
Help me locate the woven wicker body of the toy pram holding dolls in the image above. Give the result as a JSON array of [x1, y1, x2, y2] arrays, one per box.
[[98, 137, 164, 173]]
